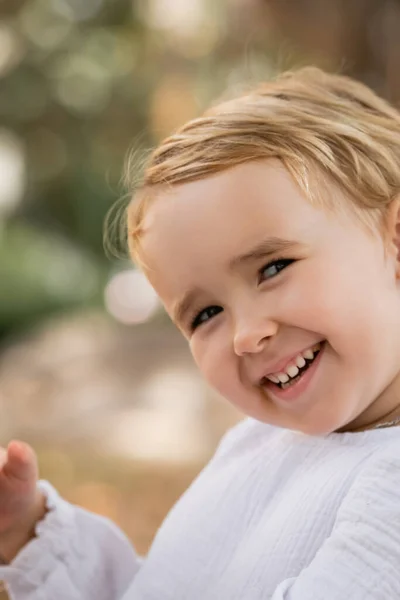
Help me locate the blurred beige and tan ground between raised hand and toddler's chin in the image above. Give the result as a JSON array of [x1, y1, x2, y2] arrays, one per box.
[[0, 313, 241, 553]]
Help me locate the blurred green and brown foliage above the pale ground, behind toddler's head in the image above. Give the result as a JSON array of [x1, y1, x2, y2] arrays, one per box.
[[0, 0, 400, 336]]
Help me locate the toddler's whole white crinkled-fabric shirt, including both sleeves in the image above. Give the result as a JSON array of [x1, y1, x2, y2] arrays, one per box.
[[0, 419, 400, 600]]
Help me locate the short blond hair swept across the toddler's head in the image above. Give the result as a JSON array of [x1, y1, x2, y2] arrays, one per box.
[[127, 67, 400, 263]]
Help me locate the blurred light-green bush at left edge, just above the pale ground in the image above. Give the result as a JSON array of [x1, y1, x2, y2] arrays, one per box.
[[0, 223, 102, 336]]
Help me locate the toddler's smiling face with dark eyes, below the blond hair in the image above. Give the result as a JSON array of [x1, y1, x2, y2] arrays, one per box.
[[142, 161, 400, 434]]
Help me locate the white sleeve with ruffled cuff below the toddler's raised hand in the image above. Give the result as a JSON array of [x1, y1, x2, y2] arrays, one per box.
[[0, 481, 141, 600]]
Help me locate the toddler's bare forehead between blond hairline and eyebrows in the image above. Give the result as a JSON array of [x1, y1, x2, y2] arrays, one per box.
[[142, 161, 344, 295]]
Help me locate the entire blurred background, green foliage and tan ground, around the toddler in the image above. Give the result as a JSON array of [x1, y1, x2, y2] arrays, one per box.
[[0, 0, 400, 568]]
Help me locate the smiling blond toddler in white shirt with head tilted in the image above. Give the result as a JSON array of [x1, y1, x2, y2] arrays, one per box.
[[0, 68, 400, 600]]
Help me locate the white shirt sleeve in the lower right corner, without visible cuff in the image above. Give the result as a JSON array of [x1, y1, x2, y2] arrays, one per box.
[[271, 444, 400, 600]]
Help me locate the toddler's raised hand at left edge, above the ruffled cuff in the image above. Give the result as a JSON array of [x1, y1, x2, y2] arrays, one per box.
[[0, 442, 46, 562]]
